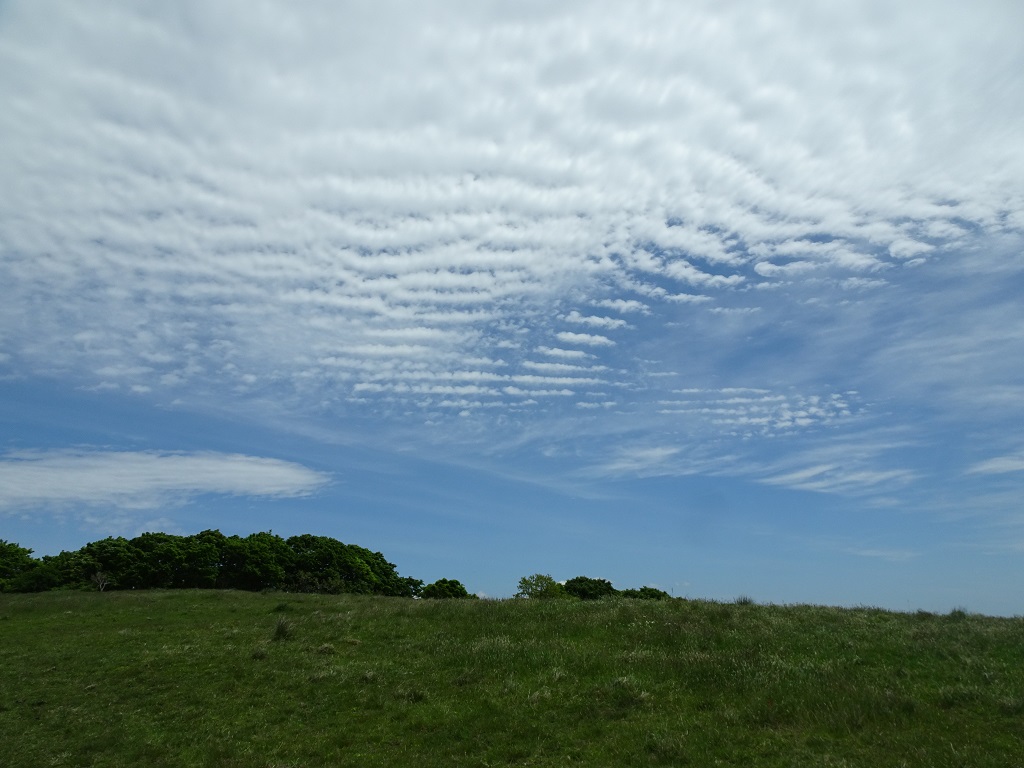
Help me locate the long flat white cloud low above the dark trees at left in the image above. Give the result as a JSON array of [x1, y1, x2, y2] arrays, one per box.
[[0, 451, 330, 511]]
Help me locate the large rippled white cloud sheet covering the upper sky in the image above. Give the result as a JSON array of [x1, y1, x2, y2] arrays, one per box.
[[0, 2, 1024, 415]]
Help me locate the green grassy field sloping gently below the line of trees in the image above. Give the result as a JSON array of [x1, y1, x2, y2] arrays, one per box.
[[0, 591, 1024, 768]]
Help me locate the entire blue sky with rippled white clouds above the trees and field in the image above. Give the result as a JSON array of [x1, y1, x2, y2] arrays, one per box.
[[0, 0, 1024, 615]]
